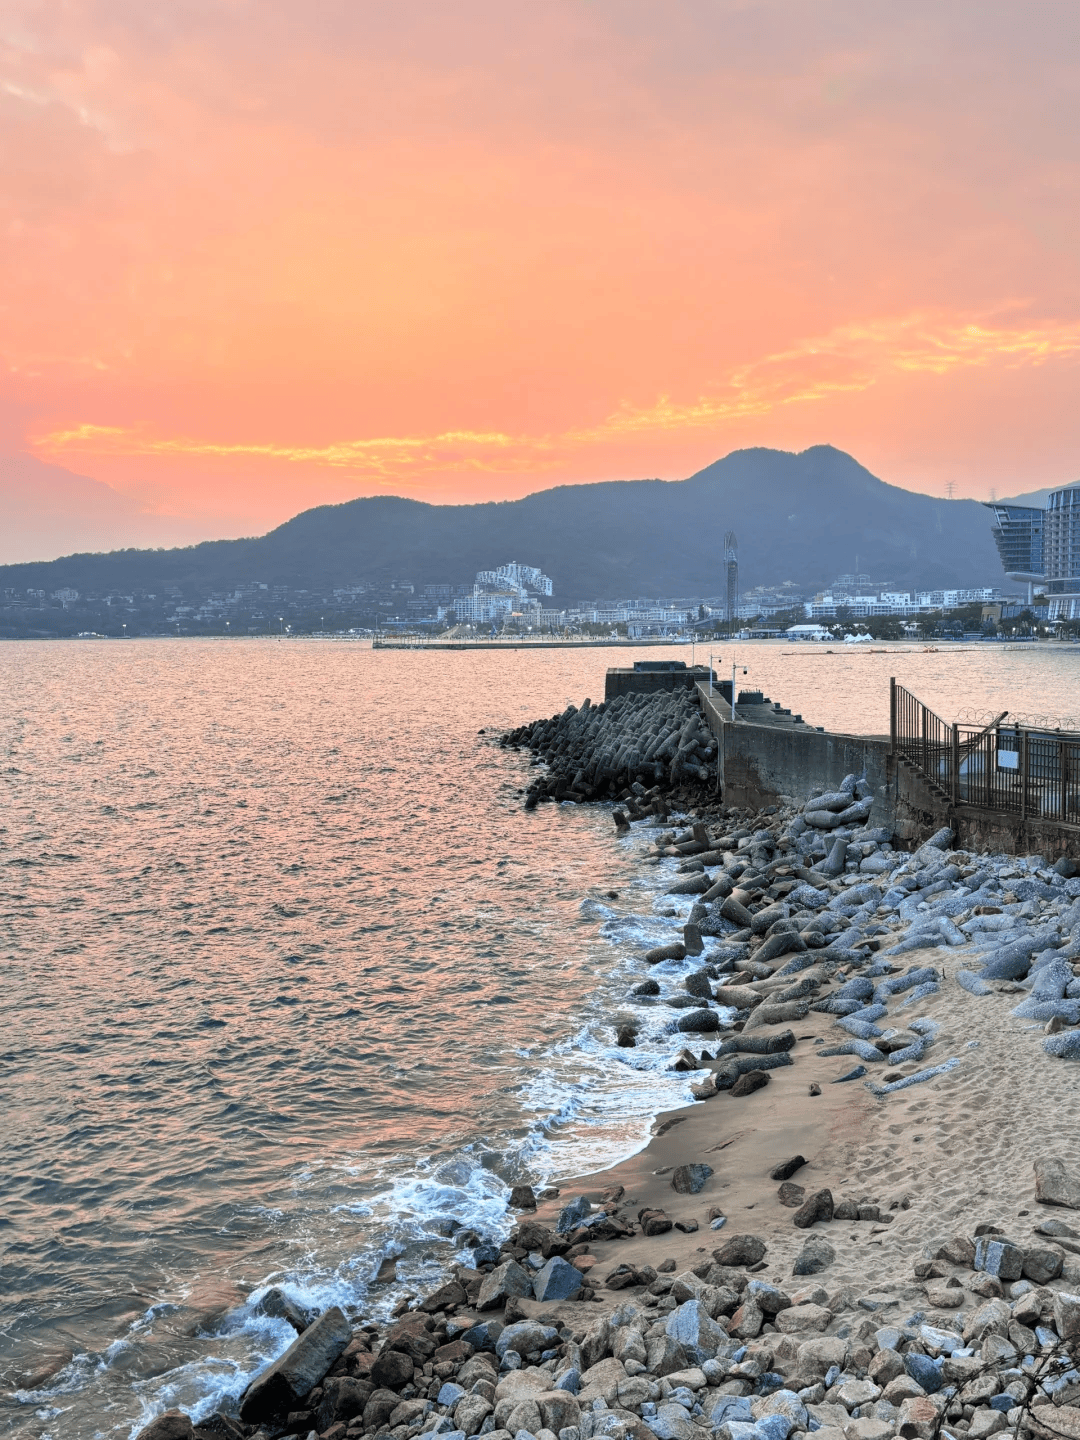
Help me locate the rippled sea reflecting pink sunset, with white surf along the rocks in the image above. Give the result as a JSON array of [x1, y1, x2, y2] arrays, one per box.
[[0, 639, 1080, 1440]]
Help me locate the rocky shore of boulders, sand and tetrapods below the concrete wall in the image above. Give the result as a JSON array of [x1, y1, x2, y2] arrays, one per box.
[[140, 696, 1080, 1440]]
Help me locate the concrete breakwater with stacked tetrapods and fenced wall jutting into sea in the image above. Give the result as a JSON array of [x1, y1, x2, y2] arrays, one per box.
[[501, 670, 1080, 858]]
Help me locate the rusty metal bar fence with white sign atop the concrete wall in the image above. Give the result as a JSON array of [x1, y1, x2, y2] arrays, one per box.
[[890, 680, 1080, 829]]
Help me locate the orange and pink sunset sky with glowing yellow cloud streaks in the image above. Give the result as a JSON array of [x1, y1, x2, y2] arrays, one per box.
[[0, 0, 1080, 536]]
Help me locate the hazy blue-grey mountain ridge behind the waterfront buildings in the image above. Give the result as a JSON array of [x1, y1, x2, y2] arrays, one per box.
[[0, 445, 1002, 603]]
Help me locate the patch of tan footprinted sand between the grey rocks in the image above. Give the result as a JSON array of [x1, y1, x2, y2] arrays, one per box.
[[529, 927, 1080, 1322]]
